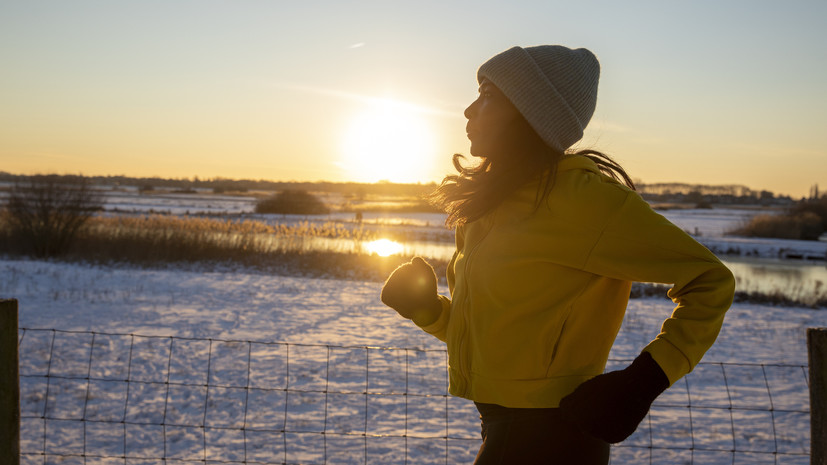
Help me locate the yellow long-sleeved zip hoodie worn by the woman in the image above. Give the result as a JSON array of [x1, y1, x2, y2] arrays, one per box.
[[422, 156, 735, 407]]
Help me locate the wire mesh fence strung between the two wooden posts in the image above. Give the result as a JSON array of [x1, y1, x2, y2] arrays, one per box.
[[18, 328, 810, 465]]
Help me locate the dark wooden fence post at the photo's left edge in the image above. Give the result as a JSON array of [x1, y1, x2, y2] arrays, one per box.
[[0, 299, 20, 465]]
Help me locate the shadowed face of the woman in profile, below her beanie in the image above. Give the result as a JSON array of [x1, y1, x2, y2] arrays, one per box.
[[465, 79, 527, 161]]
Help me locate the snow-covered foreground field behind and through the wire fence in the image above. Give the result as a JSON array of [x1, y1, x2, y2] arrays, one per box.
[[0, 260, 827, 464]]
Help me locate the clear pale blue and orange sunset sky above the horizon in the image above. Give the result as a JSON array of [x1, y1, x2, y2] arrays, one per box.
[[0, 0, 827, 198]]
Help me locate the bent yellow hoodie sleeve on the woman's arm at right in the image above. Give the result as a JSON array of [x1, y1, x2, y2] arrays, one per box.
[[585, 192, 735, 384]]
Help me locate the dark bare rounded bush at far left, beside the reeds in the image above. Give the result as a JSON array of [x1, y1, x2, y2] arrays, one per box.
[[6, 175, 104, 257]]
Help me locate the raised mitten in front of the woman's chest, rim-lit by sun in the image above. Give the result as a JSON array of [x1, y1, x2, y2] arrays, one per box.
[[380, 257, 442, 326]]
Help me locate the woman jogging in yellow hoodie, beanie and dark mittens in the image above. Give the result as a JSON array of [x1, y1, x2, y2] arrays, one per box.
[[381, 46, 734, 464]]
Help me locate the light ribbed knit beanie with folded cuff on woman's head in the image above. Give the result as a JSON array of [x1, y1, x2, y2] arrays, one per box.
[[477, 45, 600, 152]]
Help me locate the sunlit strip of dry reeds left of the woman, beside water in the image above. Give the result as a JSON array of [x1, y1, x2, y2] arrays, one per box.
[[0, 215, 446, 281]]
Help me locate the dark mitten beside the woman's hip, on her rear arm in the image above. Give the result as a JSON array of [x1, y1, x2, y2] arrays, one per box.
[[560, 352, 669, 444]]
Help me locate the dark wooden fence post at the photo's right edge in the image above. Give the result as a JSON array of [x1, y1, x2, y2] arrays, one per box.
[[807, 328, 827, 465]]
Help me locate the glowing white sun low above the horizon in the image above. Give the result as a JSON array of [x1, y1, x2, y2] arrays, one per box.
[[341, 100, 436, 182]]
